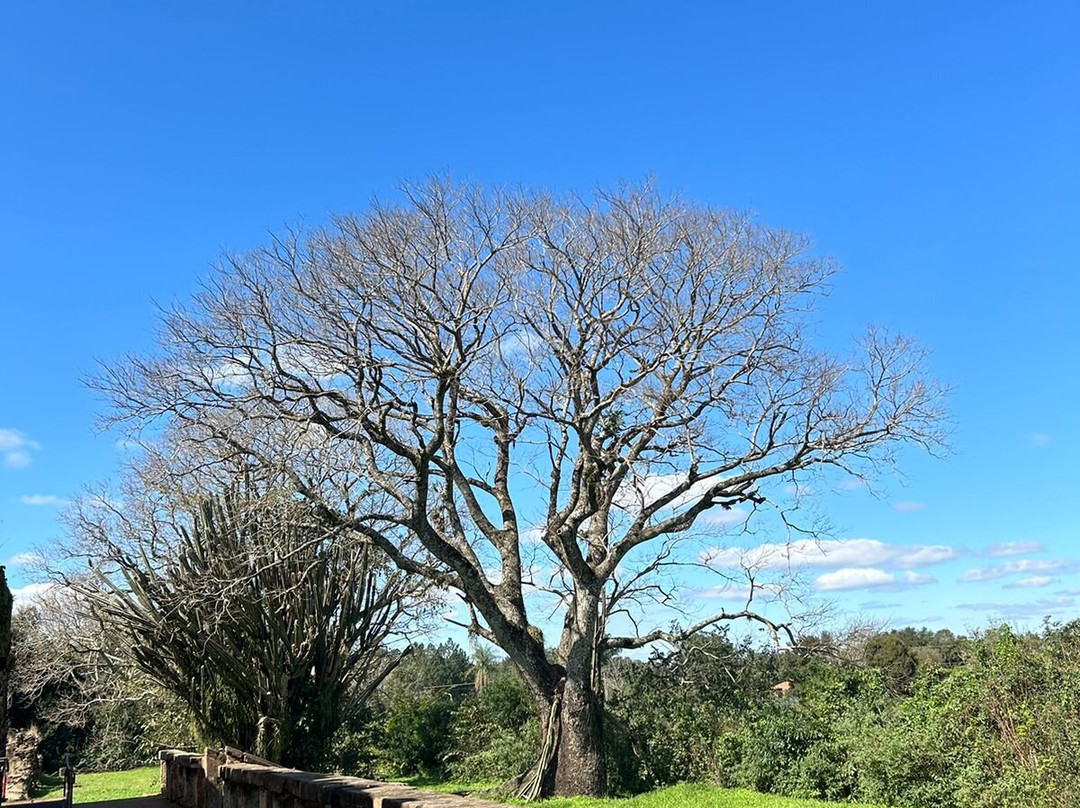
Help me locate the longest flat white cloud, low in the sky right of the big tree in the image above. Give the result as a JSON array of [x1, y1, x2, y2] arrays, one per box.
[[701, 539, 960, 569]]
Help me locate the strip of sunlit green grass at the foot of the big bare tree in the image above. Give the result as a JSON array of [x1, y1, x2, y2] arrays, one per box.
[[406, 779, 877, 808]]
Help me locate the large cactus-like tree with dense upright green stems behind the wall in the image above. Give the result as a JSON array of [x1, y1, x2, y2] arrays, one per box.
[[65, 479, 419, 767]]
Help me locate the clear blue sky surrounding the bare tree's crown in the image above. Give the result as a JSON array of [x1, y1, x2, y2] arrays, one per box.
[[0, 0, 1080, 630]]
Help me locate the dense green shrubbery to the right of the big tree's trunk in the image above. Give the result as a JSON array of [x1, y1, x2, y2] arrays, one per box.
[[608, 624, 1080, 808]]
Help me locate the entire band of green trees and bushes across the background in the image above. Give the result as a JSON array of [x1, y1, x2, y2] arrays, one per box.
[[12, 591, 1080, 808]]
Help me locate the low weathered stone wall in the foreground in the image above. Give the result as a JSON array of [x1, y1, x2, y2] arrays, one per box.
[[161, 750, 514, 808]]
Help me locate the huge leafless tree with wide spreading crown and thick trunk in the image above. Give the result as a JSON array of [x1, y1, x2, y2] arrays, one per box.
[[96, 180, 940, 796]]
